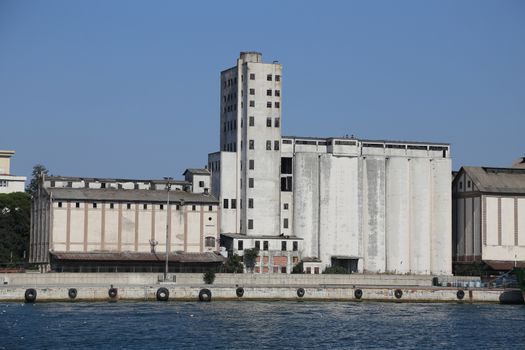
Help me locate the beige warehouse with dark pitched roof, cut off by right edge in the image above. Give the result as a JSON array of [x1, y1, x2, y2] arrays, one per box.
[[452, 158, 525, 273]]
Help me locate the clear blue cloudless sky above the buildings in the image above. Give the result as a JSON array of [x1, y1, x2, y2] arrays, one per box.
[[0, 0, 525, 178]]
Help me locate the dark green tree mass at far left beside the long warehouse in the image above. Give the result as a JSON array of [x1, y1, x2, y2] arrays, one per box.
[[0, 192, 31, 266]]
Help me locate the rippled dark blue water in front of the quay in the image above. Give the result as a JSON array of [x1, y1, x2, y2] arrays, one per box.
[[0, 301, 525, 350]]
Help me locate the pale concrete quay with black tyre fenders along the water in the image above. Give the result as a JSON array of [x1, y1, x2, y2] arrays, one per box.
[[0, 273, 504, 303]]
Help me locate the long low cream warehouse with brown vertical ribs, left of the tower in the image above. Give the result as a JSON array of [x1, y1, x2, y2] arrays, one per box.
[[30, 169, 224, 272]]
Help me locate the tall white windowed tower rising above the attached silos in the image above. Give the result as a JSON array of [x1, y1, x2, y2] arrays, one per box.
[[209, 52, 282, 236]]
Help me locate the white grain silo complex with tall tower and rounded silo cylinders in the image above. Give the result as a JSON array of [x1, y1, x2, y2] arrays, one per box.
[[208, 52, 452, 274]]
